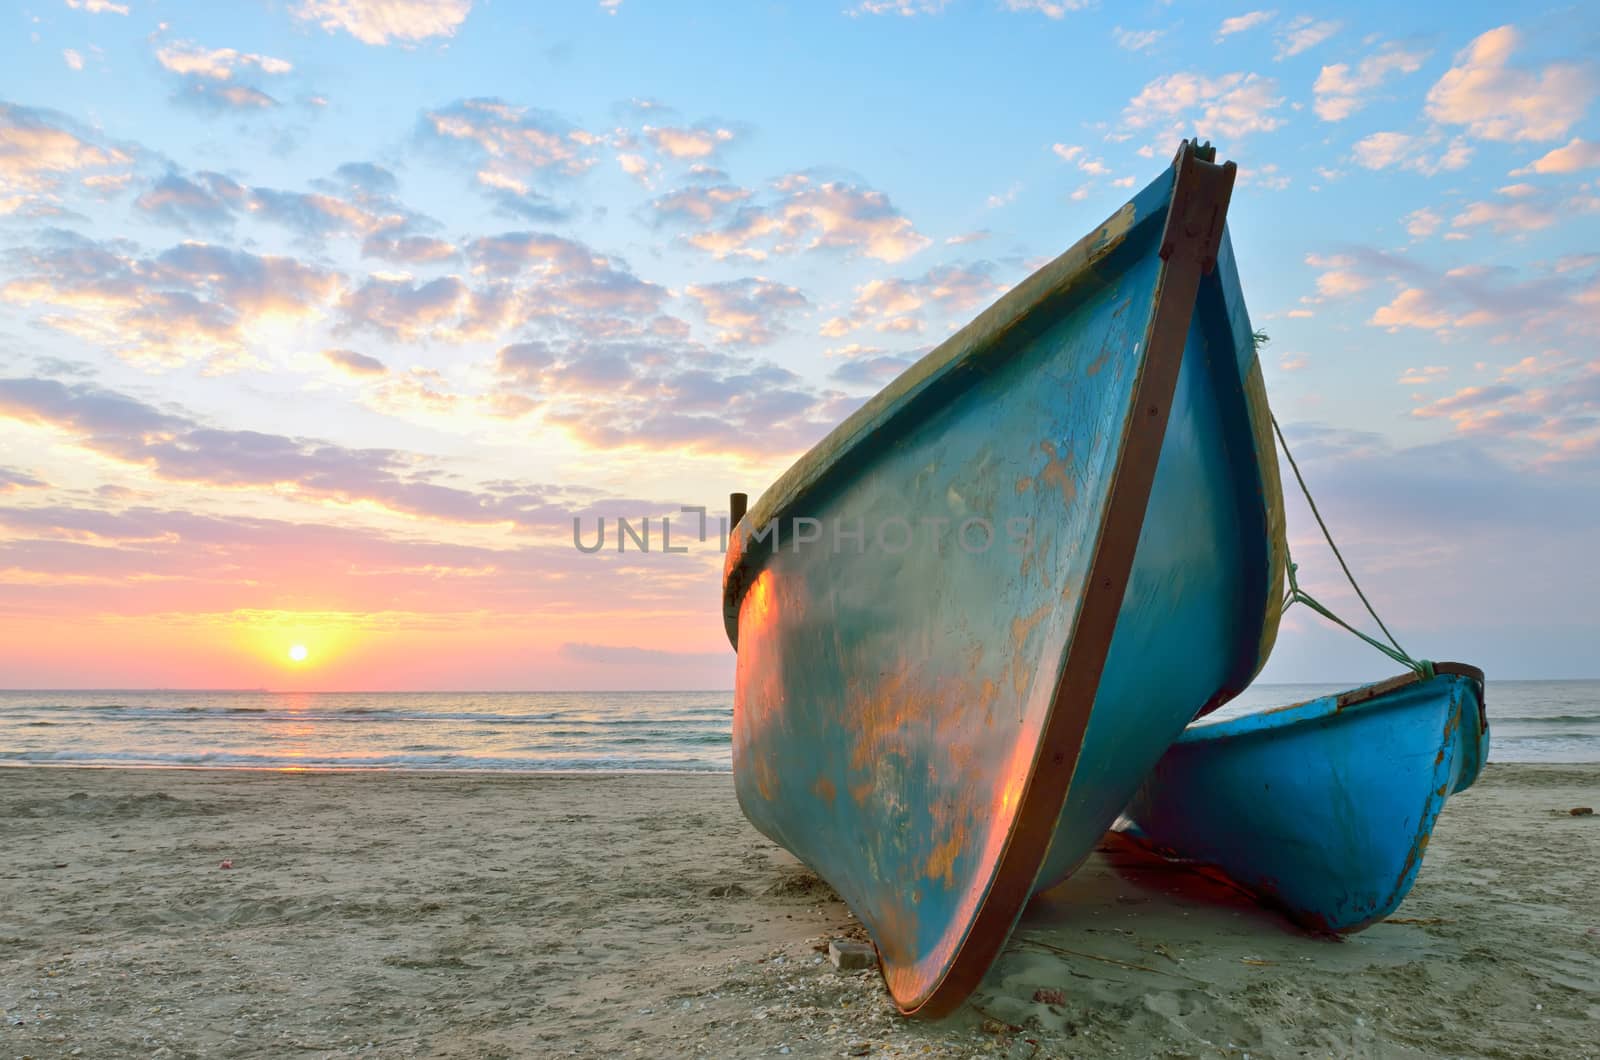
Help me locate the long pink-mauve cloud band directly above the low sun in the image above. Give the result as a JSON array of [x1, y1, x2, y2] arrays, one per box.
[[0, 499, 717, 627]]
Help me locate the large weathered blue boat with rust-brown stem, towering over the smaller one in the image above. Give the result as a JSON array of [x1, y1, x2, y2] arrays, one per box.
[[723, 141, 1285, 1015]]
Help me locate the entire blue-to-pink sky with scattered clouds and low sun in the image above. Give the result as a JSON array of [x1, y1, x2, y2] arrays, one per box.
[[0, 0, 1600, 690]]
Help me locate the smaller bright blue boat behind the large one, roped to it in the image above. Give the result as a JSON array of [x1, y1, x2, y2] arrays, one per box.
[[1125, 663, 1490, 932]]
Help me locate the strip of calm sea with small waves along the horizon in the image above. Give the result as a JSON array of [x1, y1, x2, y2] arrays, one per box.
[[0, 681, 1600, 772]]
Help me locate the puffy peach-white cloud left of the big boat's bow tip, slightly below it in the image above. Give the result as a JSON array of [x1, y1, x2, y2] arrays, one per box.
[[651, 173, 931, 261]]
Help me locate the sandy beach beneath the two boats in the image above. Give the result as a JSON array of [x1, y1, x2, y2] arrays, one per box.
[[0, 765, 1600, 1058]]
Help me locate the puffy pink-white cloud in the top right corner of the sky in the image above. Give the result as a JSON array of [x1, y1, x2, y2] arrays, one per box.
[[1426, 26, 1595, 141]]
